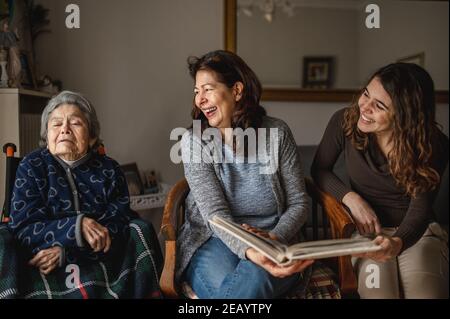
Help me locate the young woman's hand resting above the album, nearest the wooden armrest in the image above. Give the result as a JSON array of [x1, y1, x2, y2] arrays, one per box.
[[342, 192, 381, 235]]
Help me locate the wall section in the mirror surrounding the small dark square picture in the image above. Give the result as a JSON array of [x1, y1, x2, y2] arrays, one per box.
[[237, 7, 359, 88]]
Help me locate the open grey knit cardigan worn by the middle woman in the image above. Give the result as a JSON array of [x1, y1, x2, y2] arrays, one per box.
[[176, 117, 308, 280]]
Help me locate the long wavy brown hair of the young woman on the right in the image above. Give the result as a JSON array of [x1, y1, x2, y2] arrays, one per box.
[[343, 63, 440, 197]]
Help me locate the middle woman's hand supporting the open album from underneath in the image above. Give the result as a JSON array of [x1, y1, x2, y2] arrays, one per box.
[[245, 248, 314, 278]]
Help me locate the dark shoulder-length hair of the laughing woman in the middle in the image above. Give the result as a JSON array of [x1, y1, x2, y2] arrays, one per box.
[[188, 50, 266, 130]]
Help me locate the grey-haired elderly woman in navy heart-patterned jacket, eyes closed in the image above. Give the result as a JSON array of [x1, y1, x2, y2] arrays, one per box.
[[9, 91, 162, 297]]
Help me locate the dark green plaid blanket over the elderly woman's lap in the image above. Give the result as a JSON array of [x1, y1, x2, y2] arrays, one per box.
[[0, 219, 162, 299]]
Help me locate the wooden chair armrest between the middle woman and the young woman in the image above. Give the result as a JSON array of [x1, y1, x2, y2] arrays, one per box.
[[305, 177, 358, 295]]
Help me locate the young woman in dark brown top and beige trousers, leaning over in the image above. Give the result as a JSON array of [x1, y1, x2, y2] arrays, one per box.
[[312, 63, 449, 298]]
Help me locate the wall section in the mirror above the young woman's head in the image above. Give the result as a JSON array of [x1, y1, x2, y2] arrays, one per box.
[[358, 0, 449, 90]]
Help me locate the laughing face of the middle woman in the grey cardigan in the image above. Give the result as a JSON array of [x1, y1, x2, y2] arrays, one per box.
[[194, 70, 242, 131]]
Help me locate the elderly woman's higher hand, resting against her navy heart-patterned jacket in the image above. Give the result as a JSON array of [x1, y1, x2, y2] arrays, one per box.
[[81, 217, 111, 253]]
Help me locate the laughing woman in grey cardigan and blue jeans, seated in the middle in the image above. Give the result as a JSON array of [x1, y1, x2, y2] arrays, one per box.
[[177, 51, 312, 298]]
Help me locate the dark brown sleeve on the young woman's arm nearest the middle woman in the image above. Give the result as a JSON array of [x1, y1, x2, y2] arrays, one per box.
[[311, 109, 351, 202]]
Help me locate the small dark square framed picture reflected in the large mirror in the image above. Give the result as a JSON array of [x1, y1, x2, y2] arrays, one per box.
[[303, 56, 334, 89]]
